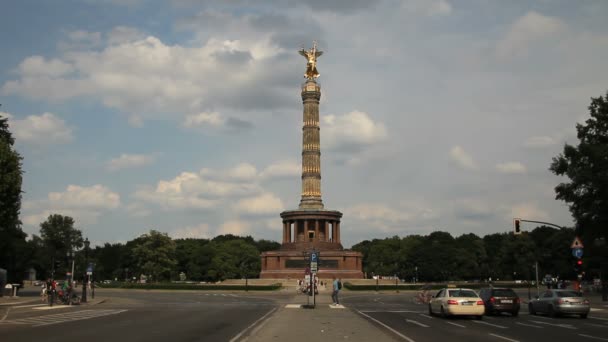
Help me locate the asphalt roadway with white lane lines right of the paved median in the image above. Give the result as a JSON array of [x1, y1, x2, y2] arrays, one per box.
[[342, 293, 608, 342]]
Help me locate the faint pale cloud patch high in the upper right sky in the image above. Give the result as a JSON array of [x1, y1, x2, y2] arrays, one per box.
[[496, 11, 566, 58]]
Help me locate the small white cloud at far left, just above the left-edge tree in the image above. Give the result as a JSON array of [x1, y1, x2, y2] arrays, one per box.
[[0, 113, 74, 146]]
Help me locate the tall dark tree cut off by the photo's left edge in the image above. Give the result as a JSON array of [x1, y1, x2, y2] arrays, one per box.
[[0, 112, 27, 282]]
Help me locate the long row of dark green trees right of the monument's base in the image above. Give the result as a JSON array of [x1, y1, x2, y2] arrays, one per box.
[[353, 226, 592, 282]]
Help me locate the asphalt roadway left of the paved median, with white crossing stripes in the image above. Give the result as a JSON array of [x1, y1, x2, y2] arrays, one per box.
[[0, 290, 281, 342]]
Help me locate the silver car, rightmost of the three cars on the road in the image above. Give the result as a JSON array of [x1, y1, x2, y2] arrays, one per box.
[[528, 289, 591, 318]]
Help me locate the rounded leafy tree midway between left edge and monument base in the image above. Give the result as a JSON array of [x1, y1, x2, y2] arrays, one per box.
[[132, 230, 177, 281]]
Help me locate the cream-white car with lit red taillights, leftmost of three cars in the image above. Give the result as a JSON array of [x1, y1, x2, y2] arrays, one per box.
[[429, 288, 485, 319]]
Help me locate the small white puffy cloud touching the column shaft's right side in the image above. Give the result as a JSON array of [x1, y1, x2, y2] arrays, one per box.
[[321, 111, 388, 151]]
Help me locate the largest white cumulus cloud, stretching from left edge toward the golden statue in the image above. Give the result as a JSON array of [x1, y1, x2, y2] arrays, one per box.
[[0, 27, 296, 121]]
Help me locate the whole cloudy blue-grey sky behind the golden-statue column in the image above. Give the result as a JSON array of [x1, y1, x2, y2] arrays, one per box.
[[0, 0, 608, 247]]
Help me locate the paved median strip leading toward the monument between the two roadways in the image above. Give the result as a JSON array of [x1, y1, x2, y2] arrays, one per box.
[[242, 291, 396, 342]]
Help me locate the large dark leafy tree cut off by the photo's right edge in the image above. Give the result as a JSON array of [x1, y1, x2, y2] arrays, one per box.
[[549, 92, 608, 245]]
